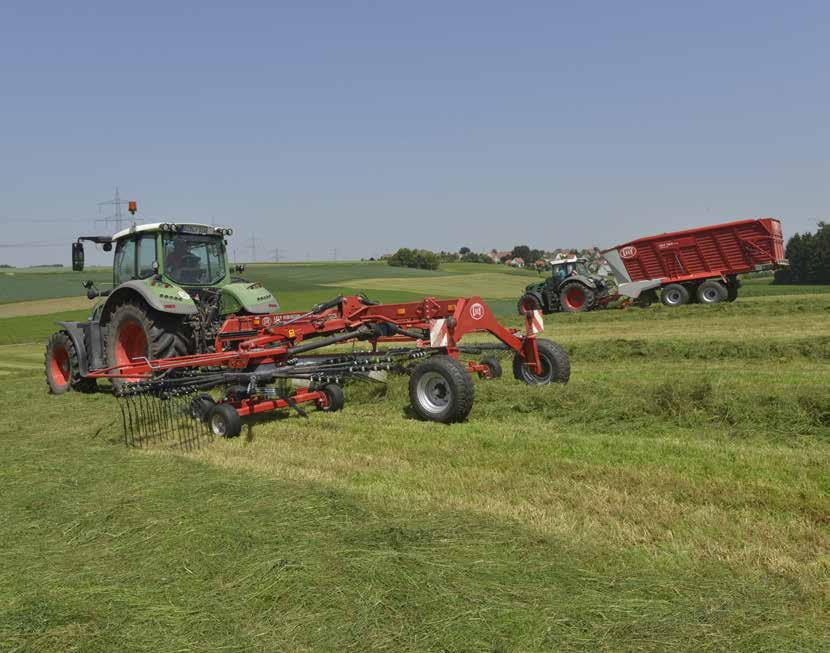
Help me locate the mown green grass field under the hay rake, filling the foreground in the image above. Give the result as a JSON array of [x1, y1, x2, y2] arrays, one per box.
[[0, 264, 830, 651]]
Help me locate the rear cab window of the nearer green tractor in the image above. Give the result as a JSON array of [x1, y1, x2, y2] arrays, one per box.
[[164, 234, 225, 286]]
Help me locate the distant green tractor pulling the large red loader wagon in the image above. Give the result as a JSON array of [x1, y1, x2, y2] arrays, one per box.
[[518, 257, 611, 315]]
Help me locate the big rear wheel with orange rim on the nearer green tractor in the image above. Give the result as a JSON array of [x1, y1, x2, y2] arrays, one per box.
[[103, 298, 190, 393]]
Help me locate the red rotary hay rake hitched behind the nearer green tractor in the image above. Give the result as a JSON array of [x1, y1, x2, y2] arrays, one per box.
[[87, 296, 570, 448]]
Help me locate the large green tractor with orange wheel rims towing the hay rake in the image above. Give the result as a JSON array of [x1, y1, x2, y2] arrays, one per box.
[[46, 223, 279, 394]]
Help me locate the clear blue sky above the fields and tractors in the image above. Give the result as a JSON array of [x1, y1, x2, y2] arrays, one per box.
[[0, 0, 830, 264]]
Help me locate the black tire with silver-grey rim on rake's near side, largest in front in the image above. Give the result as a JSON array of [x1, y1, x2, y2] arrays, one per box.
[[409, 356, 475, 424]]
